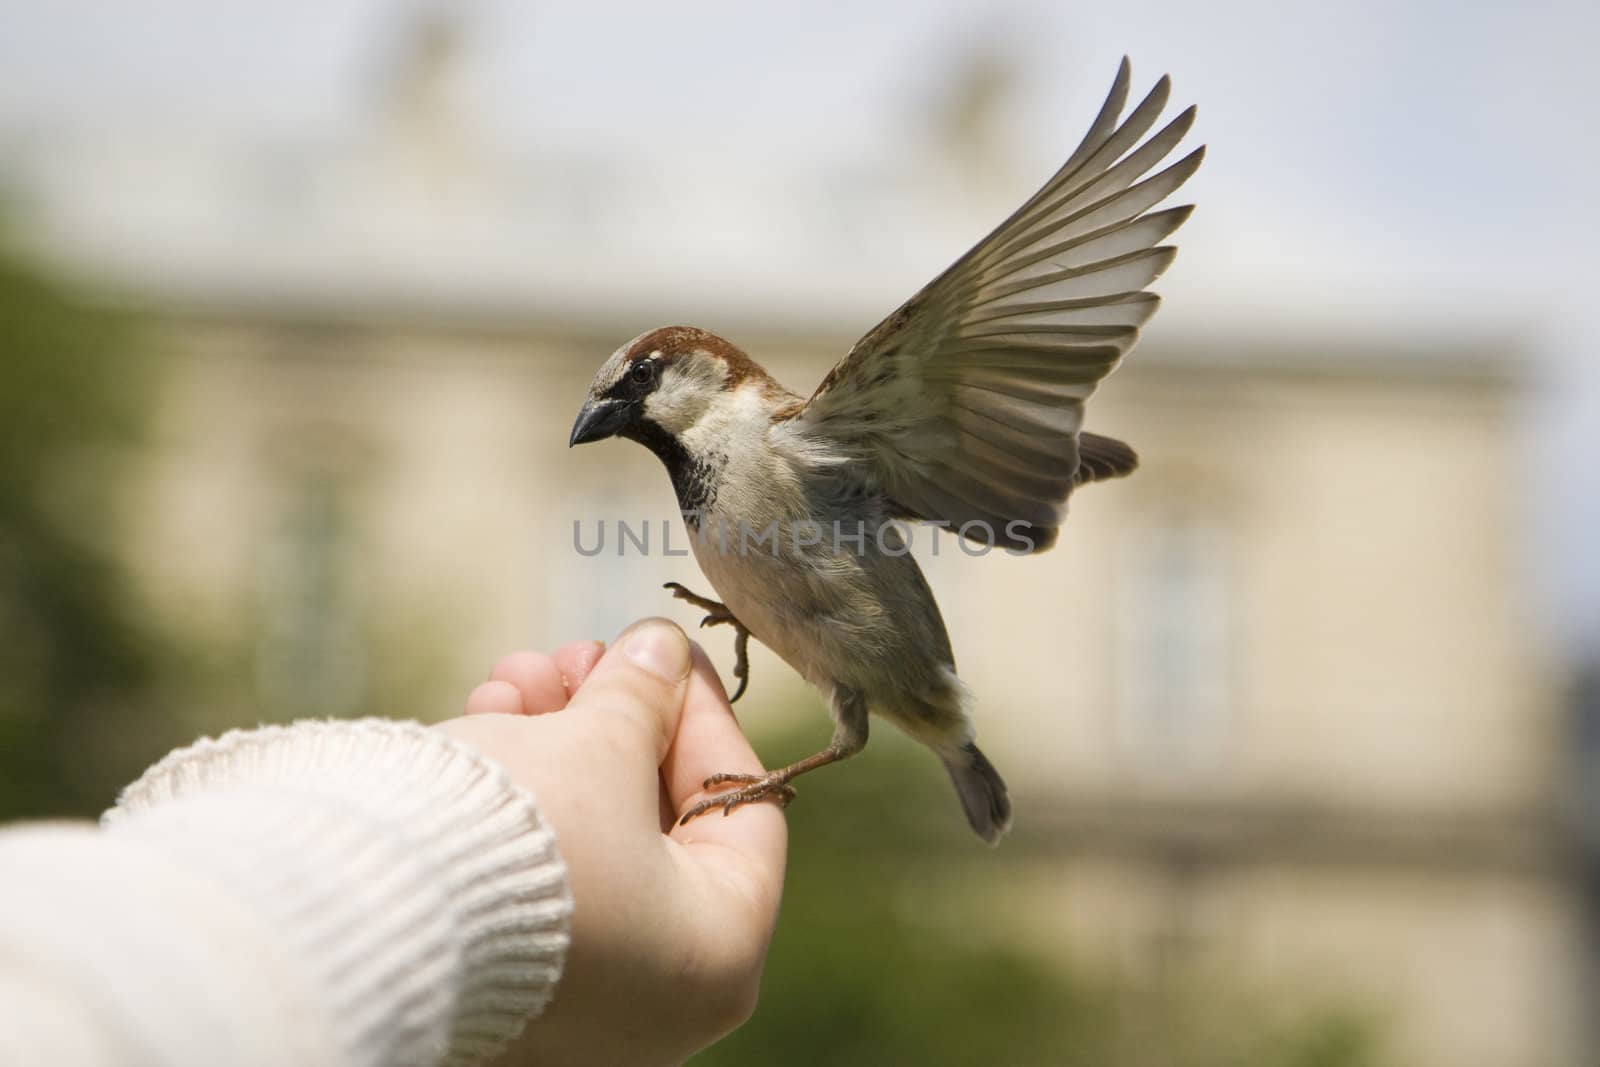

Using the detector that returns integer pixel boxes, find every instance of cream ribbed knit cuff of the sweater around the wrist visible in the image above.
[104,720,571,1065]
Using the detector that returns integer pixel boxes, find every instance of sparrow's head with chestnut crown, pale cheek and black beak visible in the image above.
[568,326,771,445]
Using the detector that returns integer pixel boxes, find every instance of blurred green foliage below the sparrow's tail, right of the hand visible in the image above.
[694,731,1379,1067]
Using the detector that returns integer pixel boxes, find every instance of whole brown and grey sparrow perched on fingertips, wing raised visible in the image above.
[568,58,1205,845]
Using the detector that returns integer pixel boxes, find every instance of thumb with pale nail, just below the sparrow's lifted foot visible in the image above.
[566,619,691,768]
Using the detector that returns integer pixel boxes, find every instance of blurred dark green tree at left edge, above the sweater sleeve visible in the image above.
[0,235,187,817]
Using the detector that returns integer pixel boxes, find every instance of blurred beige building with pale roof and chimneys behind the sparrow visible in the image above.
[3,14,1587,1067]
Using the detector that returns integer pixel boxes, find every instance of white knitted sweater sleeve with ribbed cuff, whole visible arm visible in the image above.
[0,720,571,1067]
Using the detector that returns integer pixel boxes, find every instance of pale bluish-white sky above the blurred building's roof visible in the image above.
[0,0,1600,656]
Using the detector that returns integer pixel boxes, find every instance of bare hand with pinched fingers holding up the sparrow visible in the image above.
[438,619,789,1064]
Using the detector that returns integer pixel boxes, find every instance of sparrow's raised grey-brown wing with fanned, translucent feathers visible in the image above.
[781,59,1205,552]
